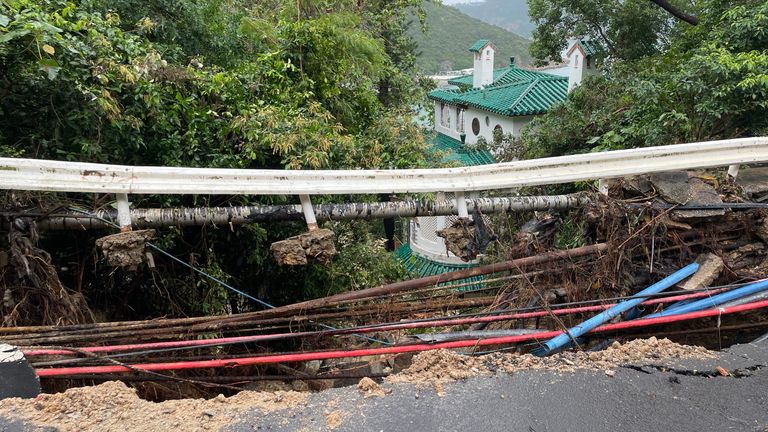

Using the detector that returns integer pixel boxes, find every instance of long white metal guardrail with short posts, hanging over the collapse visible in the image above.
[0,137,768,227]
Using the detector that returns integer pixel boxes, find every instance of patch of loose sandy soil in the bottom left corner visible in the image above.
[0,381,307,432]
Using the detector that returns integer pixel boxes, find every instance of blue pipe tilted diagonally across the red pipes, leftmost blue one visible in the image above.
[531,263,699,356]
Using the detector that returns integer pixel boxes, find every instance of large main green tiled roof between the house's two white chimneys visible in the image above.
[429,67,568,117]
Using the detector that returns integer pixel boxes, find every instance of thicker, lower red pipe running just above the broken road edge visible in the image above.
[35,300,768,377]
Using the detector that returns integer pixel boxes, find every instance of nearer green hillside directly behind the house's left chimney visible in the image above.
[410,2,530,73]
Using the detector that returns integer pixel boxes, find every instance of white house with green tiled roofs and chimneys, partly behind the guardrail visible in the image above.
[398,39,597,275]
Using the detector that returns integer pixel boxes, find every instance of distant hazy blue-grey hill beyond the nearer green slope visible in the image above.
[454,0,536,38]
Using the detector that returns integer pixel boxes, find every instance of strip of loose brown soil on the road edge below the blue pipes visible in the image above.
[388,337,717,386]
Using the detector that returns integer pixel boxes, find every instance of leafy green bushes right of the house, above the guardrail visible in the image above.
[523,0,768,157]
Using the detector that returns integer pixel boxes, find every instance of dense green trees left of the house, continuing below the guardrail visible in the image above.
[0,0,428,318]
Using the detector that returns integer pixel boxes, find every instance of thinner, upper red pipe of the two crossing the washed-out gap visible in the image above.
[22,288,725,357]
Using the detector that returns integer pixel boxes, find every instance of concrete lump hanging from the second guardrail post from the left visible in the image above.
[269,229,336,265]
